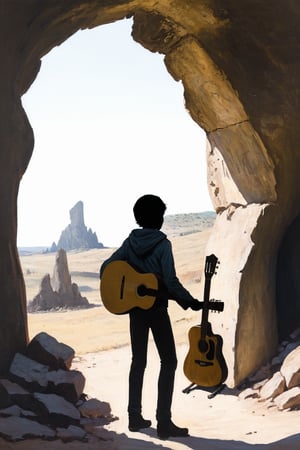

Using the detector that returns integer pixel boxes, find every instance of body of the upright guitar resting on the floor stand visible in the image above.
[183,324,227,387]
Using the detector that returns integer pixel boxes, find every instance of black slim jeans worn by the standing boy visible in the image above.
[128,305,177,421]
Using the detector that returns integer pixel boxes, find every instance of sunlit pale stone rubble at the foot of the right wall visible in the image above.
[239,328,300,410]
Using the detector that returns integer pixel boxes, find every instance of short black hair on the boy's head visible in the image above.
[133,194,167,230]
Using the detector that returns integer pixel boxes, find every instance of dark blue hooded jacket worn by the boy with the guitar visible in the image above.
[100,228,194,309]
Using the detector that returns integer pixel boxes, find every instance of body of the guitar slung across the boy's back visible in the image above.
[100,260,158,314]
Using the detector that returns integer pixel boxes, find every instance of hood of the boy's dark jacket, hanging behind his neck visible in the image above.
[128,228,167,256]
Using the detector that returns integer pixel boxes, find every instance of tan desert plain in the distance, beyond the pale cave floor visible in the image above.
[21,216,210,355]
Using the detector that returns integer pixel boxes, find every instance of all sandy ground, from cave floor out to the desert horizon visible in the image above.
[0,216,300,450]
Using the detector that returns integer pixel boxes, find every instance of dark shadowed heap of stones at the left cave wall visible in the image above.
[0,332,117,442]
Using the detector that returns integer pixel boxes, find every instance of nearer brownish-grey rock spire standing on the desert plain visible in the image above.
[28,249,90,312]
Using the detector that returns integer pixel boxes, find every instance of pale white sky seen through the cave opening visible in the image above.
[18,20,213,247]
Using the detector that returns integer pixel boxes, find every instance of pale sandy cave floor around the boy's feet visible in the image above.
[0,341,300,450]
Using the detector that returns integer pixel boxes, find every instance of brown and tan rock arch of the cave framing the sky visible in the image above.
[0,0,300,386]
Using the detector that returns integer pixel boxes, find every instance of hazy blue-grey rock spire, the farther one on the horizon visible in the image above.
[51,201,103,251]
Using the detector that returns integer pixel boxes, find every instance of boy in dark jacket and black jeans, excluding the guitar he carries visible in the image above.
[100,194,201,439]
